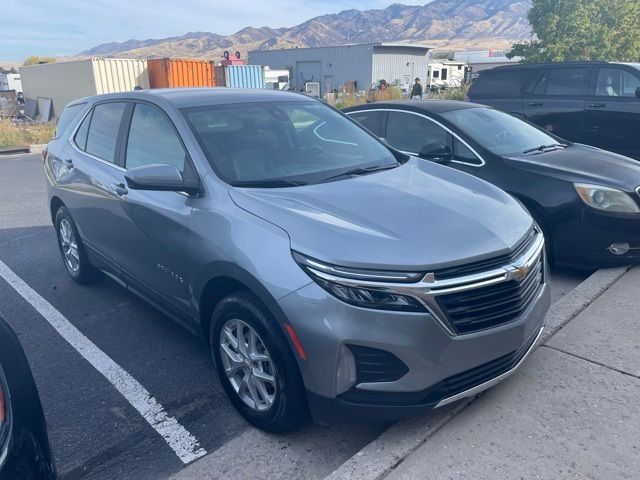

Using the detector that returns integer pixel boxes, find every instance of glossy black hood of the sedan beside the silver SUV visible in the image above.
[506,144,640,192]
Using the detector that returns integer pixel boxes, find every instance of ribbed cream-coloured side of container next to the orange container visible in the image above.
[91,58,149,93]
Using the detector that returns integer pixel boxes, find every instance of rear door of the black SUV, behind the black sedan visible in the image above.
[523,66,591,142]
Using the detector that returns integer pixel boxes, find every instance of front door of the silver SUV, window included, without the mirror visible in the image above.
[109,102,195,315]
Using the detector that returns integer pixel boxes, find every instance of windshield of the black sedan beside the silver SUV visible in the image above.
[442,107,565,155]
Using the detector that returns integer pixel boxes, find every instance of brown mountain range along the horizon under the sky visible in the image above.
[78,0,531,60]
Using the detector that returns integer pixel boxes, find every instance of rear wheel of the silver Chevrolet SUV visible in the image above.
[55,207,100,284]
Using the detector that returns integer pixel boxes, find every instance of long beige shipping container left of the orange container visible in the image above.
[20,58,149,120]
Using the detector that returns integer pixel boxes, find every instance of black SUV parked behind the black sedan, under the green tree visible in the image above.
[468,62,640,160]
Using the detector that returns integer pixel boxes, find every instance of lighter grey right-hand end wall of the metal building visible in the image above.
[371,46,429,84]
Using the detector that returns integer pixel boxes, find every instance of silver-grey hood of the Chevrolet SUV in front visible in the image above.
[229,158,532,271]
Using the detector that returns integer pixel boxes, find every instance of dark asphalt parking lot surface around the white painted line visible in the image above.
[0,155,588,480]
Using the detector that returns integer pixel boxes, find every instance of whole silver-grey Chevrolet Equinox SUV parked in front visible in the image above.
[44,88,550,431]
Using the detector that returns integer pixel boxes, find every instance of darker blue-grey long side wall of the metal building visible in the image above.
[249,44,374,94]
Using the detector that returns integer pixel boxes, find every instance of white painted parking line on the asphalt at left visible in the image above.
[0,260,207,463]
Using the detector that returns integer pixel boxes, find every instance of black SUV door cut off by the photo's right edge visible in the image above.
[584,65,640,159]
